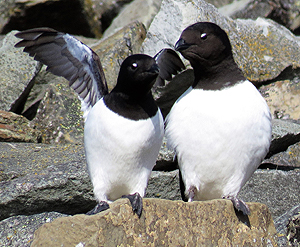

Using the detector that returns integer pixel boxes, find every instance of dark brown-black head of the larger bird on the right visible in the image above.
[175,22,232,67]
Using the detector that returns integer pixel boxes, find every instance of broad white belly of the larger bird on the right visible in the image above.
[166,81,271,200]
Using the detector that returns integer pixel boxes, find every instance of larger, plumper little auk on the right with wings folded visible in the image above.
[166,22,272,215]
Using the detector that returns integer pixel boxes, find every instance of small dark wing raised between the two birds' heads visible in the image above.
[154,49,185,87]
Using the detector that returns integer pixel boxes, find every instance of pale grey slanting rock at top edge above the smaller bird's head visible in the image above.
[103,0,162,37]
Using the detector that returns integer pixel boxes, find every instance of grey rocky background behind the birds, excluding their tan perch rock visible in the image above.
[0,0,300,246]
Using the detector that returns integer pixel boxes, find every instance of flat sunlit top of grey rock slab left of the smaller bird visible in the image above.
[0,142,85,182]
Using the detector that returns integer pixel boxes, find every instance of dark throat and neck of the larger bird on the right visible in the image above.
[192,56,245,90]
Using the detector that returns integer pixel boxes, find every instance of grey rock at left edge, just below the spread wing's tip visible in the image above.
[0,29,41,114]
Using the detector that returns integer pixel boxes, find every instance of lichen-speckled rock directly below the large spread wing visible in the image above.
[31,73,84,144]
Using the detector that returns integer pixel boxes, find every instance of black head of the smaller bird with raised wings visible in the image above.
[115,54,159,97]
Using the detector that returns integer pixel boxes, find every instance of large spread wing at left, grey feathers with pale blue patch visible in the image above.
[15,28,108,117]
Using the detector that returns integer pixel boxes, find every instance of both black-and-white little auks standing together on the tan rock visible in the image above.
[16,22,271,217]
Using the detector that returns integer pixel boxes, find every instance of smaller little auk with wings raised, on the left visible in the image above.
[15,28,184,217]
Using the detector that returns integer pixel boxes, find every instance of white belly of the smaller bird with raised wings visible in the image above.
[84,99,164,201]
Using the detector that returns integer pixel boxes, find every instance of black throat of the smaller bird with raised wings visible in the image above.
[104,90,158,121]
